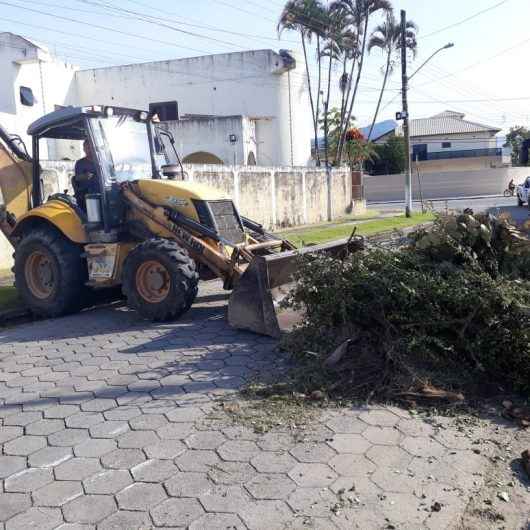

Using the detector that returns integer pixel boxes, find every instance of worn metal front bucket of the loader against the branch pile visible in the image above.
[228,239,359,338]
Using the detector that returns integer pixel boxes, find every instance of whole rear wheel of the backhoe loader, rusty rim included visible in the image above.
[13,228,87,318]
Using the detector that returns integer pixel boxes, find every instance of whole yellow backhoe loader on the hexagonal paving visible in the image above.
[0,106,351,336]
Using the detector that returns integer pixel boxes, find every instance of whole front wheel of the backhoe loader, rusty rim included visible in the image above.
[122,239,199,321]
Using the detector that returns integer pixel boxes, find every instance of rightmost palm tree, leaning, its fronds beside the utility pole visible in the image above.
[368,12,418,140]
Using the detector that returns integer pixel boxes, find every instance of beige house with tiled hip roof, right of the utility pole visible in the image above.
[374,110,510,173]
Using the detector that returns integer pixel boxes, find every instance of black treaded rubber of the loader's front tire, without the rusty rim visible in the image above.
[122,238,199,322]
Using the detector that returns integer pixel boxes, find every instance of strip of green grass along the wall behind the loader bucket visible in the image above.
[280,213,435,247]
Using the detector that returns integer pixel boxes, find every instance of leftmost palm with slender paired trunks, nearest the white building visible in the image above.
[278,0,327,165]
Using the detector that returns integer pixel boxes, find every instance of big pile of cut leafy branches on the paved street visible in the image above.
[284,214,530,403]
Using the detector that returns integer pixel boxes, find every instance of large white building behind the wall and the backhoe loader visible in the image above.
[0,33,312,166]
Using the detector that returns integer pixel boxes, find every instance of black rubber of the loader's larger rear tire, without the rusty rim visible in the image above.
[13,227,87,318]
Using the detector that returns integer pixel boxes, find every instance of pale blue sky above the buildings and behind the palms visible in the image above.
[0,0,530,129]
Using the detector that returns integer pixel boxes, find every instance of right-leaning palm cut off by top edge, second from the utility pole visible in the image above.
[330,0,392,163]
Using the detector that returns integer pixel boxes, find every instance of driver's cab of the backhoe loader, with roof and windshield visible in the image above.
[28,106,167,233]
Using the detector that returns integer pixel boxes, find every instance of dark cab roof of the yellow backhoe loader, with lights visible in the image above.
[28,105,147,140]
